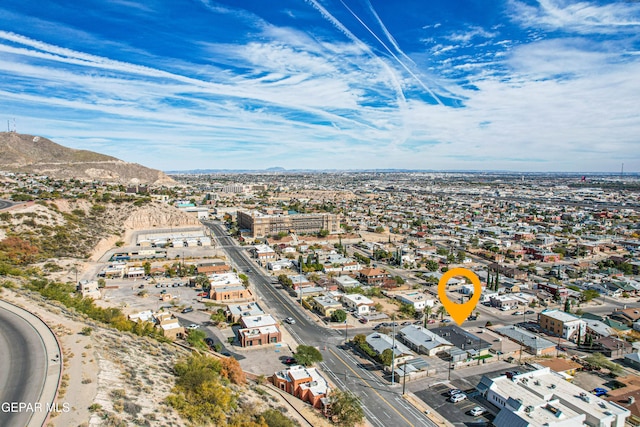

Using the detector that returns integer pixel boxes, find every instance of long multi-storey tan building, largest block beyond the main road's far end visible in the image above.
[238,211,340,238]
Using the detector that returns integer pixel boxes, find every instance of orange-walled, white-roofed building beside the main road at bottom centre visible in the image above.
[271,365,330,409]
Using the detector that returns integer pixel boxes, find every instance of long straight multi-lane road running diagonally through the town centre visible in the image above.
[205,221,436,427]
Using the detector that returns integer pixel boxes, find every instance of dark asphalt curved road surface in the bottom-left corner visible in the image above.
[0,308,47,427]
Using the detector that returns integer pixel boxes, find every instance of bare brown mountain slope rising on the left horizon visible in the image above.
[0,132,175,185]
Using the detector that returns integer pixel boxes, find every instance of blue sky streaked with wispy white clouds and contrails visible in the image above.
[0,0,640,172]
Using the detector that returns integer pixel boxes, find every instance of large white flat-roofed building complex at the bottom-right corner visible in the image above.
[477,368,630,427]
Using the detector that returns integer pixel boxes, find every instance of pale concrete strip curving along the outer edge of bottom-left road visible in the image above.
[0,300,62,427]
